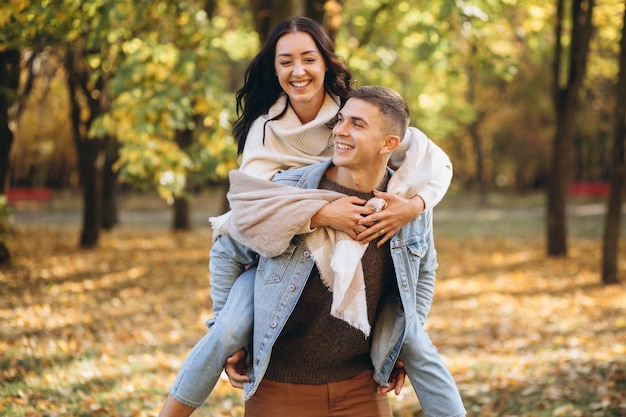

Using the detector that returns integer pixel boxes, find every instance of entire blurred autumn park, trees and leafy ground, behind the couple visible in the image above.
[0,0,626,417]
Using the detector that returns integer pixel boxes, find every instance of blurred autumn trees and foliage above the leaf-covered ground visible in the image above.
[0,0,626,256]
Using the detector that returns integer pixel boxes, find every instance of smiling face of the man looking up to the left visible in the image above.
[333,98,385,168]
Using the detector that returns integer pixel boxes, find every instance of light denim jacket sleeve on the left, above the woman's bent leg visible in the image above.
[209,235,258,317]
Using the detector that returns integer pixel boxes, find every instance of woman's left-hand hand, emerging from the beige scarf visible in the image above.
[311,197,374,239]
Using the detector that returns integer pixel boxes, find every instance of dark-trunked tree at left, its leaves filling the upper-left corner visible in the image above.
[0,0,141,247]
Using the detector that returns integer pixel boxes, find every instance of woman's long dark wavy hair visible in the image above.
[233,17,352,154]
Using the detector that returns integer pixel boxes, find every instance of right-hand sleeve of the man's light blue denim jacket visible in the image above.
[415,210,438,325]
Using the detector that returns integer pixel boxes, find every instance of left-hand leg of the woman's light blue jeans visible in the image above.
[170,268,256,408]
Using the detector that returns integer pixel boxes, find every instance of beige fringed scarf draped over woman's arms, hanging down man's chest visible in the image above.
[210,128,447,336]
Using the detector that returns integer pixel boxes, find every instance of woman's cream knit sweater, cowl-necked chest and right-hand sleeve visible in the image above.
[234,94,452,207]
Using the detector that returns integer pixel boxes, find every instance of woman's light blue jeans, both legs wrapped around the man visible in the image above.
[170,268,465,417]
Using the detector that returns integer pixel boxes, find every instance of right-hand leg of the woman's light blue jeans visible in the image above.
[398,320,466,417]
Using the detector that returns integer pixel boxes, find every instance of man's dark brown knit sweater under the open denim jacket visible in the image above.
[265,171,395,384]
